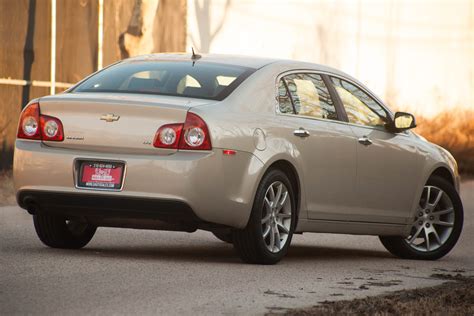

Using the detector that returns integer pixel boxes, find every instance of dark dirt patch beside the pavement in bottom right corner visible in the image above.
[283,274,474,316]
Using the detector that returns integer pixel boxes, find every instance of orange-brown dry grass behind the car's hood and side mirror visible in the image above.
[415,110,474,175]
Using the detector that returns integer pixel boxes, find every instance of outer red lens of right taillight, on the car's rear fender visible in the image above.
[179,112,212,150]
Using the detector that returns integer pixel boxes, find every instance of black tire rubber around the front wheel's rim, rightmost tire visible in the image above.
[379,176,464,260]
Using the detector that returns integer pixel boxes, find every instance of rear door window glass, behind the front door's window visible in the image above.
[279,73,337,120]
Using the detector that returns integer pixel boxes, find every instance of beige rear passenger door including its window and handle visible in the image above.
[279,72,356,219]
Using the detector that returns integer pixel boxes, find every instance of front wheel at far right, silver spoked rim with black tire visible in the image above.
[380,177,463,260]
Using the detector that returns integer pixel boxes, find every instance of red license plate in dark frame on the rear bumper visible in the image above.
[77,161,124,190]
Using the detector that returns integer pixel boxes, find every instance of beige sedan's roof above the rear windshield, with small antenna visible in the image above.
[123,53,347,76]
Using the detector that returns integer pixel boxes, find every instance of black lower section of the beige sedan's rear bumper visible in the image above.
[17,190,208,231]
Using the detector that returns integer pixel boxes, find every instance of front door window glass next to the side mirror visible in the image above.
[331,77,389,127]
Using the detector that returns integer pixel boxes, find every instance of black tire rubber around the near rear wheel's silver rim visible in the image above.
[232,169,297,264]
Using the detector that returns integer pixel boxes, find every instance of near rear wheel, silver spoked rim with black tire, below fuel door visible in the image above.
[233,169,296,264]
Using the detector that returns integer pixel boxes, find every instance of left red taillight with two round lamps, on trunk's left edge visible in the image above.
[17,103,64,142]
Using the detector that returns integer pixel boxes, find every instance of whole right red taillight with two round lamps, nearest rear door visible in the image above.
[153,112,212,150]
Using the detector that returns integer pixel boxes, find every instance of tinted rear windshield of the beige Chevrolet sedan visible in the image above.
[72,61,255,100]
